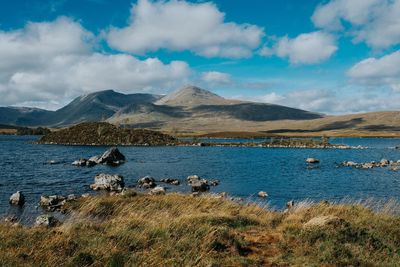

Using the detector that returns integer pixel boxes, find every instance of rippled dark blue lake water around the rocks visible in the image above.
[0,136,400,223]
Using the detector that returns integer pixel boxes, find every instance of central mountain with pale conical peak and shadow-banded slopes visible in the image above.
[108,86,323,128]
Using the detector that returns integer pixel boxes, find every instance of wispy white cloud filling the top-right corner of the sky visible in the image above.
[312,0,400,48]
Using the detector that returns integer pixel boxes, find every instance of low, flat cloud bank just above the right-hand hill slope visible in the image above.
[252,89,400,114]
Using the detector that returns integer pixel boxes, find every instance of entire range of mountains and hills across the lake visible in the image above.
[0,86,400,136]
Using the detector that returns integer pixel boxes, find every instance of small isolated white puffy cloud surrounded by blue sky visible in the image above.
[261,31,338,64]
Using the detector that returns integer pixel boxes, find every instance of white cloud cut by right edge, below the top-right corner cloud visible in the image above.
[347,51,400,90]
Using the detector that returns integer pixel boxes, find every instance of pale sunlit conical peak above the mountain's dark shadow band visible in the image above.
[156,85,239,107]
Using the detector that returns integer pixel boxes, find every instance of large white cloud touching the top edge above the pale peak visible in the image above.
[107,0,264,58]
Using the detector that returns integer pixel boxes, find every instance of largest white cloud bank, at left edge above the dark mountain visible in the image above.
[0,17,191,107]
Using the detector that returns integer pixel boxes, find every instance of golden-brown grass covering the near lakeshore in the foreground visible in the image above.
[0,194,400,266]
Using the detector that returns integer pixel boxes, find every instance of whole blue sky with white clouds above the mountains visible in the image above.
[0,0,400,114]
